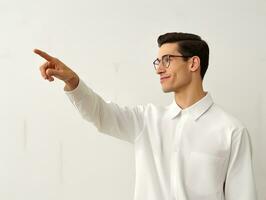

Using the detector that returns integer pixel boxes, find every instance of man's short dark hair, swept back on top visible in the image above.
[157,32,209,79]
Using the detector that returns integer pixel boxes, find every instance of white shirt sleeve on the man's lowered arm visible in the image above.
[225,128,257,200]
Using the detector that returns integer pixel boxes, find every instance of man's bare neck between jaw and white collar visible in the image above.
[175,81,207,109]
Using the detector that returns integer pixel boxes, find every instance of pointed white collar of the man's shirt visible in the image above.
[168,92,213,121]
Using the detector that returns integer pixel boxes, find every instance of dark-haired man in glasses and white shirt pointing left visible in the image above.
[35,33,256,200]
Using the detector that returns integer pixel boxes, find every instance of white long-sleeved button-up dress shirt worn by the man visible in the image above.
[66,80,257,200]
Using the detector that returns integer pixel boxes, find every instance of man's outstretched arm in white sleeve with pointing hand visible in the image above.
[34,49,147,143]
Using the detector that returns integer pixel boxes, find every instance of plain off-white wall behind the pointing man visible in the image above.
[0,0,266,200]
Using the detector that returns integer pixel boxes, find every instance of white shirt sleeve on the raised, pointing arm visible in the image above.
[65,79,145,143]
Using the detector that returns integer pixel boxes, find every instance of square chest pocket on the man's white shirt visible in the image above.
[185,152,225,196]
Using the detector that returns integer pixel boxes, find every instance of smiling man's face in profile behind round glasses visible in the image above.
[156,43,192,92]
